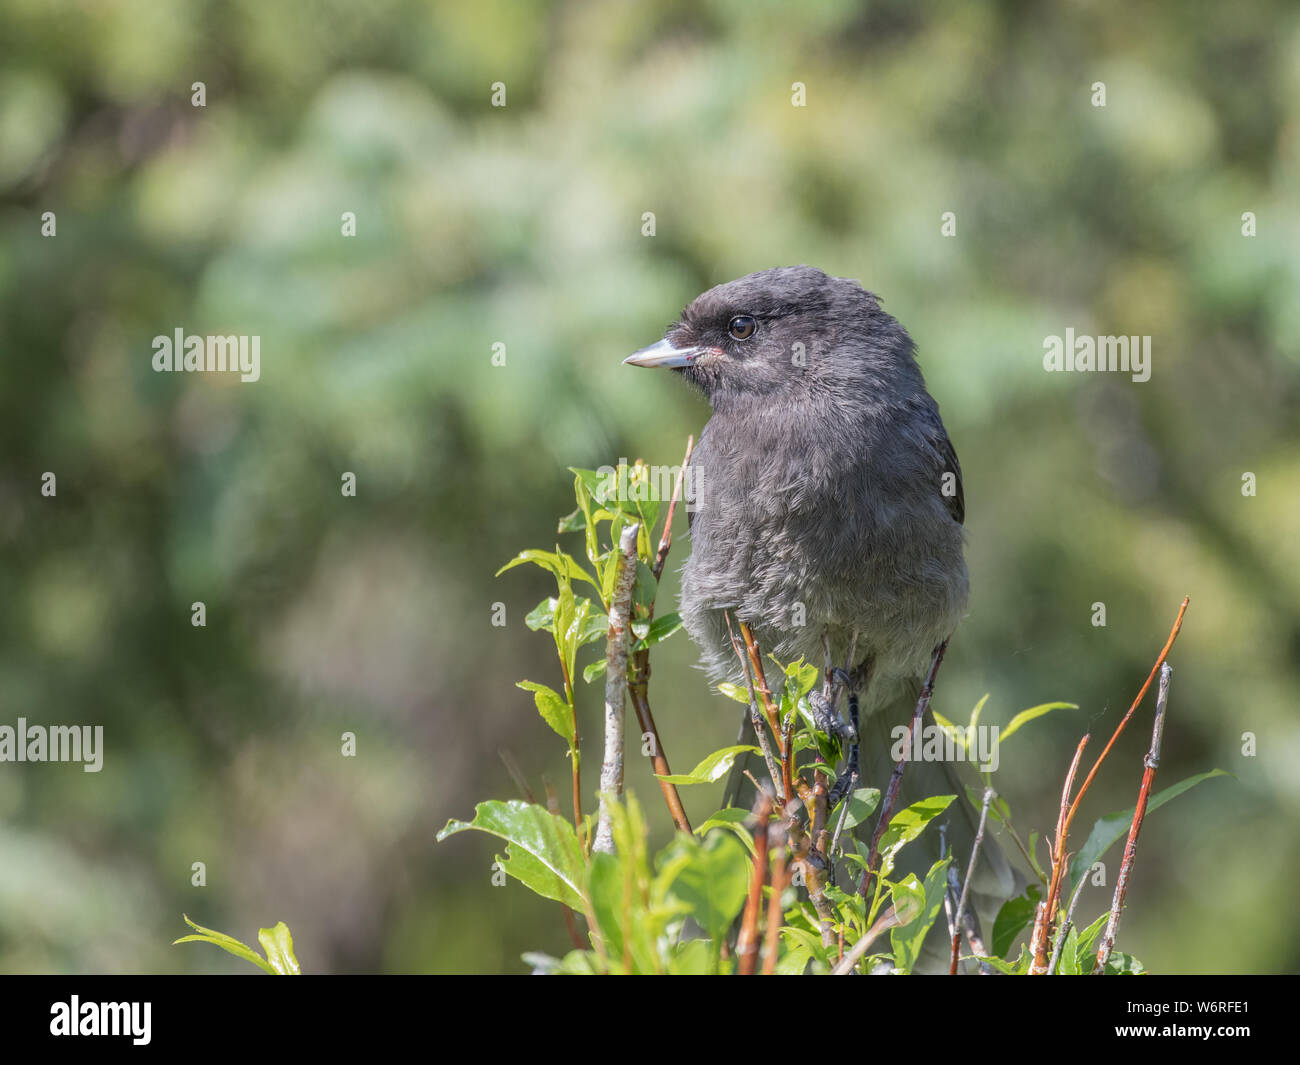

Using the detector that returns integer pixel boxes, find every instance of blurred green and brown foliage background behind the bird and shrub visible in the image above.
[0,0,1300,973]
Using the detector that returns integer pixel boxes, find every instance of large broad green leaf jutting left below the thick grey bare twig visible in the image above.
[438,798,586,912]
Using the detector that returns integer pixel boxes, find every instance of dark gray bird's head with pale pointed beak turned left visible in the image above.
[624,267,915,407]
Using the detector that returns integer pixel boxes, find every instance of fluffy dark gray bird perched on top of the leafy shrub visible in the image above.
[625,267,1014,967]
